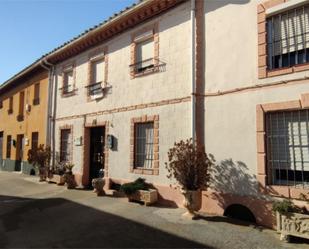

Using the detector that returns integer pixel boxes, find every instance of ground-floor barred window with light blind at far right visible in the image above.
[266,110,309,188]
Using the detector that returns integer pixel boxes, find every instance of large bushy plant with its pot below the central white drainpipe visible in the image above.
[165,139,215,218]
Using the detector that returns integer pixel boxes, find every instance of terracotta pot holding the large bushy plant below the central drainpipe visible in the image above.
[182,190,201,219]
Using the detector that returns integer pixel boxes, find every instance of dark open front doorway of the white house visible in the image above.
[89,127,105,185]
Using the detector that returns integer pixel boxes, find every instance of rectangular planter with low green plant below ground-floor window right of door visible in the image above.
[120,178,158,206]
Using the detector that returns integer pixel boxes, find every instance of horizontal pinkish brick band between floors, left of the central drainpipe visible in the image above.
[56,97,191,121]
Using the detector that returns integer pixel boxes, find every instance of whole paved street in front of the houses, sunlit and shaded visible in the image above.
[0,172,309,249]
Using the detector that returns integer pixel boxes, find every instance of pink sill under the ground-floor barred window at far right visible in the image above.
[261,185,309,199]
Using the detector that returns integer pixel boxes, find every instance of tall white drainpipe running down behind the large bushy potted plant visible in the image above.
[191,0,196,145]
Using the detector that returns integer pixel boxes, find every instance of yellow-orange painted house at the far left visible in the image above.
[0,66,48,174]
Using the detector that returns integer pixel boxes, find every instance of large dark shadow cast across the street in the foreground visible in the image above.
[0,196,211,248]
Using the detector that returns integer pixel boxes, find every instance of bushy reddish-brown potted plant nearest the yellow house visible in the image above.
[28,144,51,181]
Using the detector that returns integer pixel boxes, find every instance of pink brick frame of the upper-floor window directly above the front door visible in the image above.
[86,46,108,102]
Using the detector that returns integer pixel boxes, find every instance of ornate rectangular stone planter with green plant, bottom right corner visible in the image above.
[272,199,309,242]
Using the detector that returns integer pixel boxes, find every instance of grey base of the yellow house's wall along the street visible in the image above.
[0,159,38,175]
